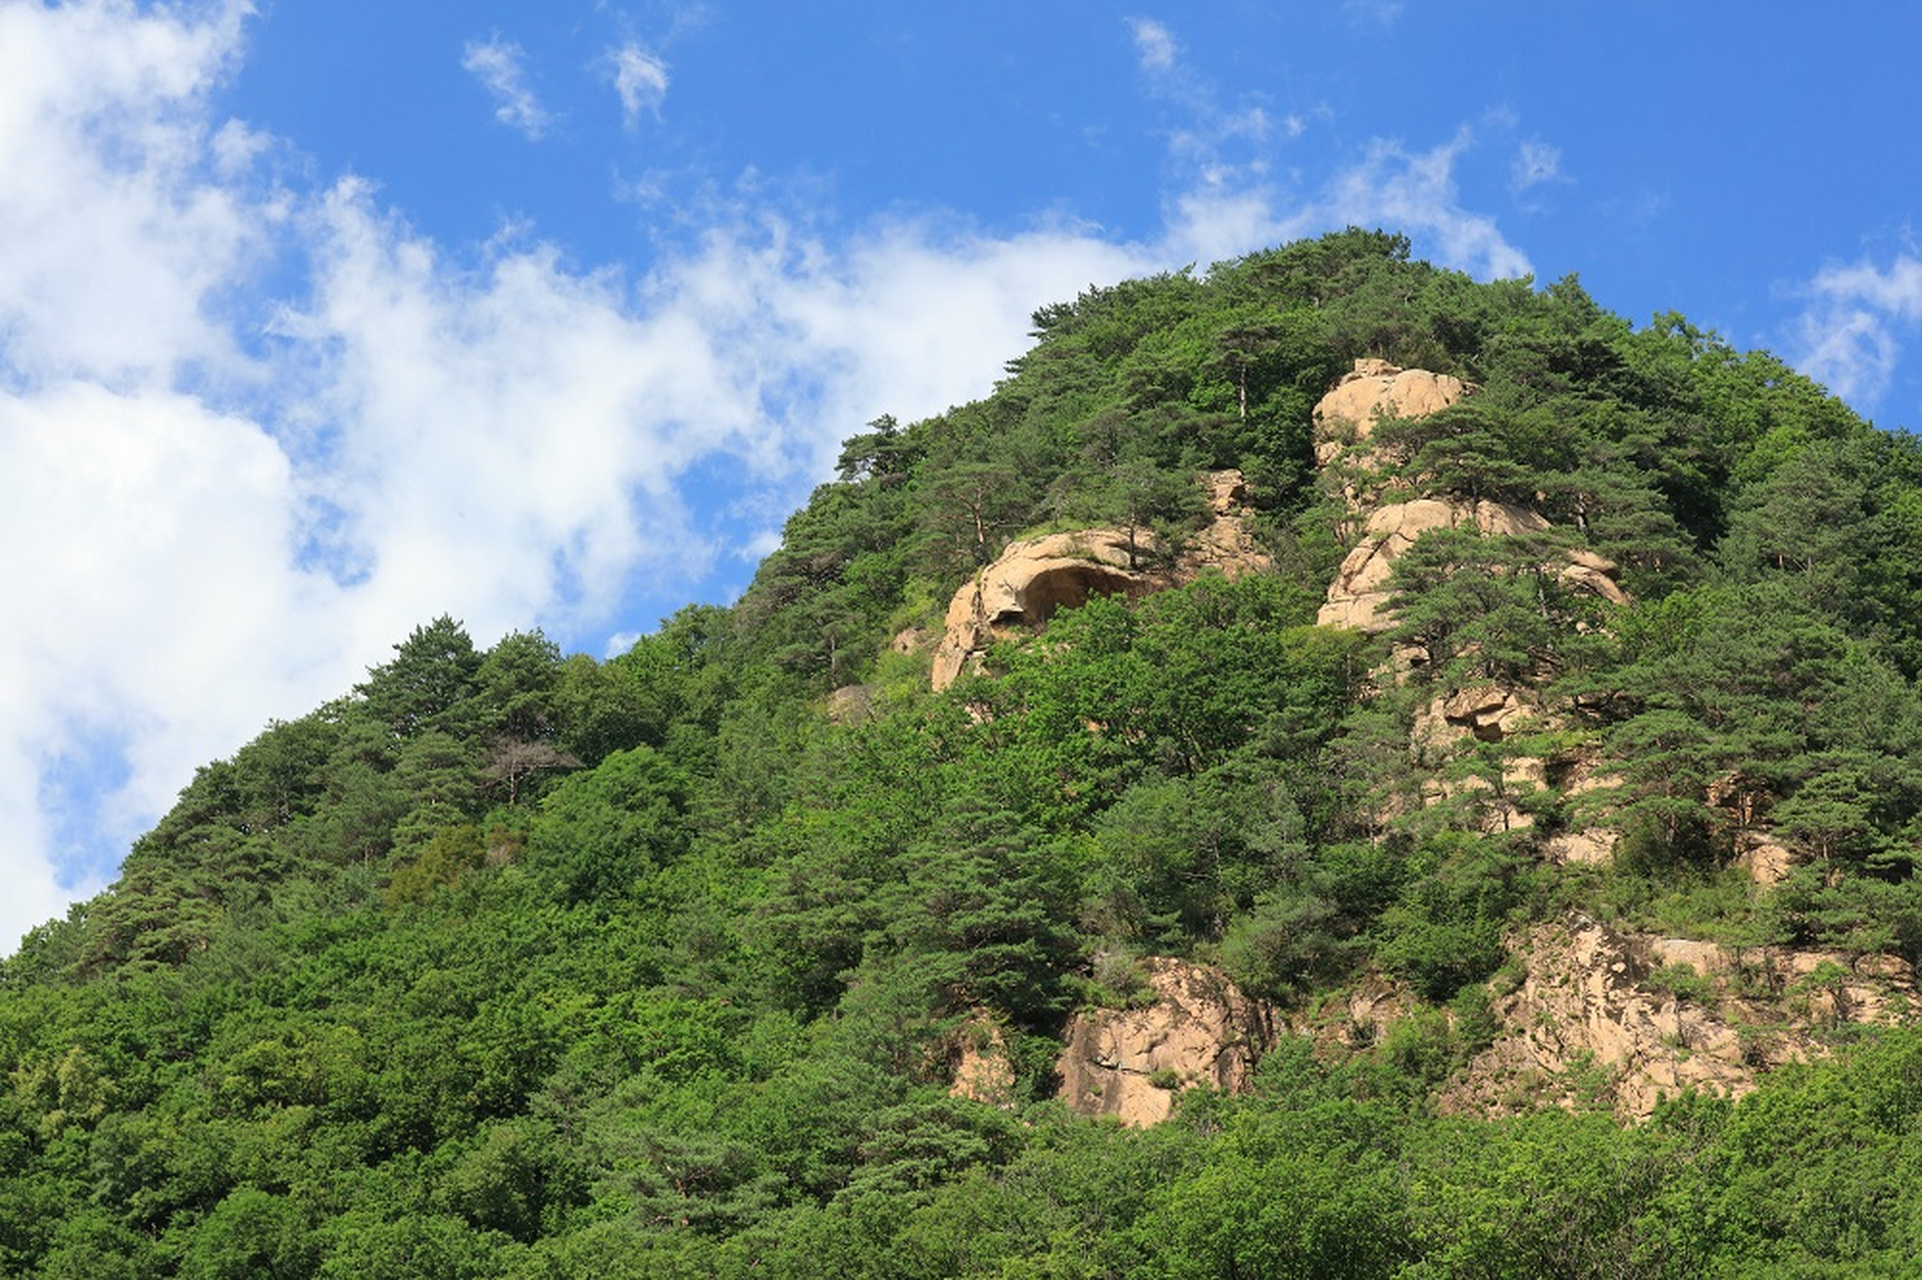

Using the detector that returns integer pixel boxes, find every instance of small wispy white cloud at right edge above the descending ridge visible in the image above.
[1791,254,1922,406]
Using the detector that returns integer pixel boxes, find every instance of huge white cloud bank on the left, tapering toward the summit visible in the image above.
[0,4,1149,946]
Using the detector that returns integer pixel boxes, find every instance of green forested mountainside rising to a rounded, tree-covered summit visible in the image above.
[0,231,1922,1280]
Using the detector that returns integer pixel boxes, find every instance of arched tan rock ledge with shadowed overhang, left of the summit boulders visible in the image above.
[934,469,1269,690]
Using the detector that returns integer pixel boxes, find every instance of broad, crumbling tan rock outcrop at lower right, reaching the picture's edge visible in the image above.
[1443,915,1914,1119]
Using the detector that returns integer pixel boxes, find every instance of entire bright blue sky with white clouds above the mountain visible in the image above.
[0,0,1922,946]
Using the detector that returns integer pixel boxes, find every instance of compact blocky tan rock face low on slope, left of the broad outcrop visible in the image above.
[1055,957,1274,1124]
